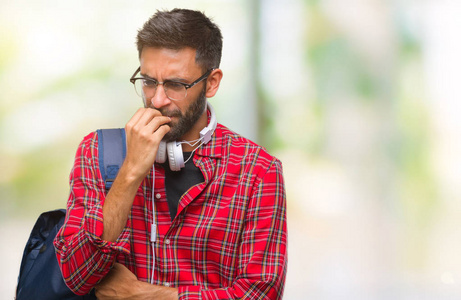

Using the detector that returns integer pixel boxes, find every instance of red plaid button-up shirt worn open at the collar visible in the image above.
[55,124,287,299]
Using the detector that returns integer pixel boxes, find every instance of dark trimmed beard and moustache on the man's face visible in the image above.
[157,86,206,142]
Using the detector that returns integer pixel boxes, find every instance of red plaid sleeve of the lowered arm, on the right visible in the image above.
[178,158,288,300]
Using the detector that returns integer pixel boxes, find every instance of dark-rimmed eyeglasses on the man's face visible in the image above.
[130,67,214,101]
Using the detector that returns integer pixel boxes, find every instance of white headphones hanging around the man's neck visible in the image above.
[155,101,217,171]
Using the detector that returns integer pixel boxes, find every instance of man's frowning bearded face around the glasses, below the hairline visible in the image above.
[140,48,206,142]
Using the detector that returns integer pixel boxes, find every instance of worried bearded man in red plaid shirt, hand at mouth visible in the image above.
[55,9,287,299]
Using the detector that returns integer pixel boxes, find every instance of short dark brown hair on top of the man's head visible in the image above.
[136,8,222,70]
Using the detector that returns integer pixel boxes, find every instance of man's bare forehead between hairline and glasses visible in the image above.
[140,47,201,78]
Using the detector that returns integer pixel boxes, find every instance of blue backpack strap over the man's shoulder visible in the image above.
[96,128,126,191]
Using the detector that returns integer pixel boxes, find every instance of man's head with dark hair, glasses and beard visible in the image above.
[130,9,223,141]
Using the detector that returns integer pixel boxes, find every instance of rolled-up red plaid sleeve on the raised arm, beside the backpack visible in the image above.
[54,133,130,295]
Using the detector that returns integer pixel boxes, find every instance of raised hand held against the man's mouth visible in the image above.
[125,108,171,180]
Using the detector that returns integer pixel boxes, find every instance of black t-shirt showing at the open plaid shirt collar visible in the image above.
[162,152,205,221]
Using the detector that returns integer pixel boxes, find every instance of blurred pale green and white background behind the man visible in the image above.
[0,0,461,299]
